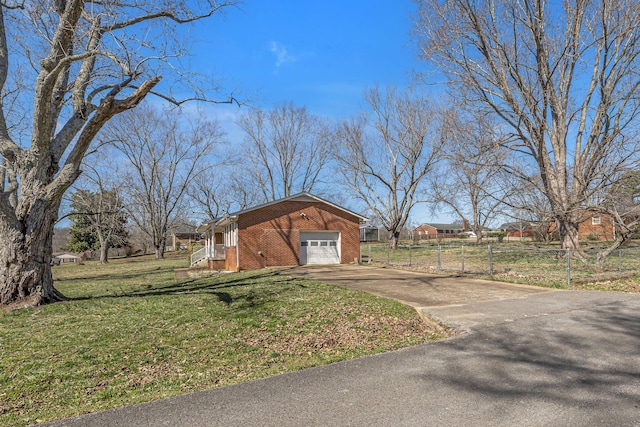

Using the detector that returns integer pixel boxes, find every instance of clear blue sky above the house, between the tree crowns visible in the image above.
[182,0,448,222]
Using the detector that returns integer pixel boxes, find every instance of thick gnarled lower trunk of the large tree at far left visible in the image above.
[0,202,65,306]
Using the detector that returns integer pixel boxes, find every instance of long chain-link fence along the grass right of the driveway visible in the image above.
[360,244,640,285]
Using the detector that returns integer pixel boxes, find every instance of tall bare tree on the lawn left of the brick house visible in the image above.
[100,105,222,259]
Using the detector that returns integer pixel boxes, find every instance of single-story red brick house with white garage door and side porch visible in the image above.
[192,193,367,271]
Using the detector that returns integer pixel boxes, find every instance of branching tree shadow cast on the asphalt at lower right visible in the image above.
[418,300,640,425]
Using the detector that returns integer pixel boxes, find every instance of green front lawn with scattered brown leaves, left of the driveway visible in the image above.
[0,257,438,426]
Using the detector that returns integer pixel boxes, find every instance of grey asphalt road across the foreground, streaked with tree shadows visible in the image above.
[45,268,640,426]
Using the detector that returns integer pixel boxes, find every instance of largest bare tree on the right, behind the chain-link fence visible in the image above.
[415,0,640,257]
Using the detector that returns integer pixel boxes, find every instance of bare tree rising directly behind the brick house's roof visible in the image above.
[237,104,333,201]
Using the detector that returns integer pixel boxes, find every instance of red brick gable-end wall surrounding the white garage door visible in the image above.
[238,201,360,270]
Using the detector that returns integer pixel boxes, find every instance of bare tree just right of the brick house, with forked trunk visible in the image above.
[337,88,442,248]
